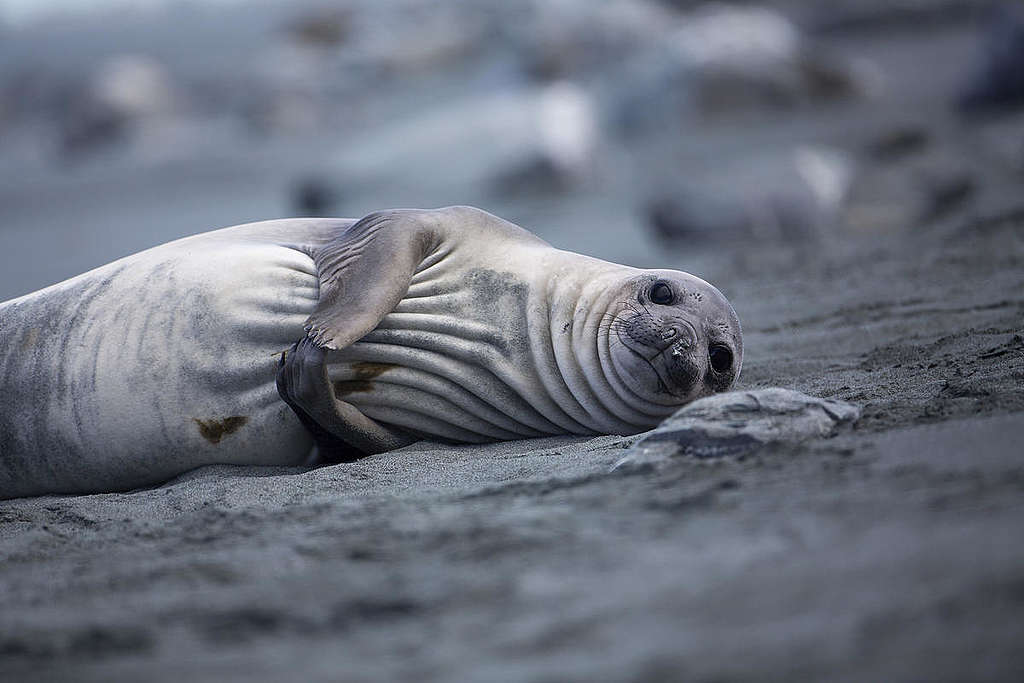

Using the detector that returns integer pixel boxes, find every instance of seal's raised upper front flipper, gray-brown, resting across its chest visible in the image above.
[305,209,437,349]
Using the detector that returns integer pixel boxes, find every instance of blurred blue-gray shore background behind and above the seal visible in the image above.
[0,0,1024,299]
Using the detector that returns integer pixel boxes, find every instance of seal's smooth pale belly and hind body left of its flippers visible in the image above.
[0,240,317,498]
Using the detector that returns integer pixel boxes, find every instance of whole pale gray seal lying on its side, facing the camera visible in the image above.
[0,207,742,498]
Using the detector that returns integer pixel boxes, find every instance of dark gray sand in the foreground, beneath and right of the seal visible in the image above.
[0,225,1024,681]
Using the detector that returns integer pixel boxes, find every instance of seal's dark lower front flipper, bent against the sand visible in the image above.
[278,337,416,462]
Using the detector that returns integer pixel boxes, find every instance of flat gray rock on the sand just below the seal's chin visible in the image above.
[612,387,860,470]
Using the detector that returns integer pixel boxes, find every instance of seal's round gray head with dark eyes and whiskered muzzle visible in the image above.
[608,270,743,405]
